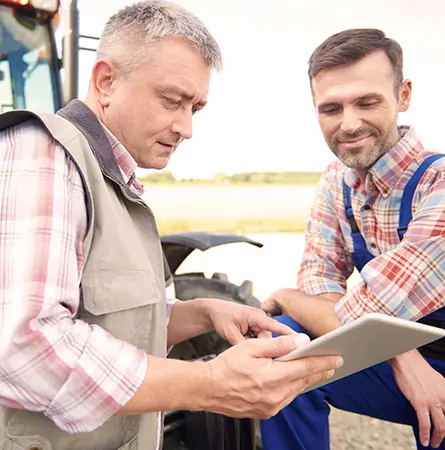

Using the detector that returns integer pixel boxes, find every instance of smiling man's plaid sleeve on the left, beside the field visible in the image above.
[298,163,354,295]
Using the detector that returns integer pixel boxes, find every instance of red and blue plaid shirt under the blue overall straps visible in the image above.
[298,127,445,323]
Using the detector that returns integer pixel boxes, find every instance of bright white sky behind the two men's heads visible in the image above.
[71,0,445,178]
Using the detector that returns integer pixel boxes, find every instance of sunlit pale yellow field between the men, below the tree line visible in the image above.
[140,183,315,234]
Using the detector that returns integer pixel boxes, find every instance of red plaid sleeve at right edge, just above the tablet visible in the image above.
[336,167,445,323]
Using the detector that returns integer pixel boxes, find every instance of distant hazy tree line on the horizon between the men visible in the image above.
[139,170,321,185]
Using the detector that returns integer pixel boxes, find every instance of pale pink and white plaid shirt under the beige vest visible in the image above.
[0,118,176,433]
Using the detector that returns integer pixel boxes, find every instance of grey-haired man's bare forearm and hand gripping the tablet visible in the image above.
[119,333,342,419]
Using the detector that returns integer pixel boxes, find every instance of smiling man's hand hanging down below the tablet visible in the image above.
[390,350,445,448]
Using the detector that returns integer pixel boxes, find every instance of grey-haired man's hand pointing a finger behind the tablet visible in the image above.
[205,299,296,345]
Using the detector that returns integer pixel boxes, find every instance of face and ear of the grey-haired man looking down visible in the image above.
[87,37,211,169]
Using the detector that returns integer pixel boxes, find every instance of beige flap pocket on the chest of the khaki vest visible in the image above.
[82,270,165,316]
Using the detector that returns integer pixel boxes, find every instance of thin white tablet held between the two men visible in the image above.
[276,313,445,392]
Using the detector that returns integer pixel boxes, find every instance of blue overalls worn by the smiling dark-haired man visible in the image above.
[261,155,445,450]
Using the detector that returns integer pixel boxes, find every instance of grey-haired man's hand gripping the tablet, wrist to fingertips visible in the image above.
[201,334,342,419]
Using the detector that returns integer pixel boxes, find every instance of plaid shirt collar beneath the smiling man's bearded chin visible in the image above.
[345,126,423,198]
